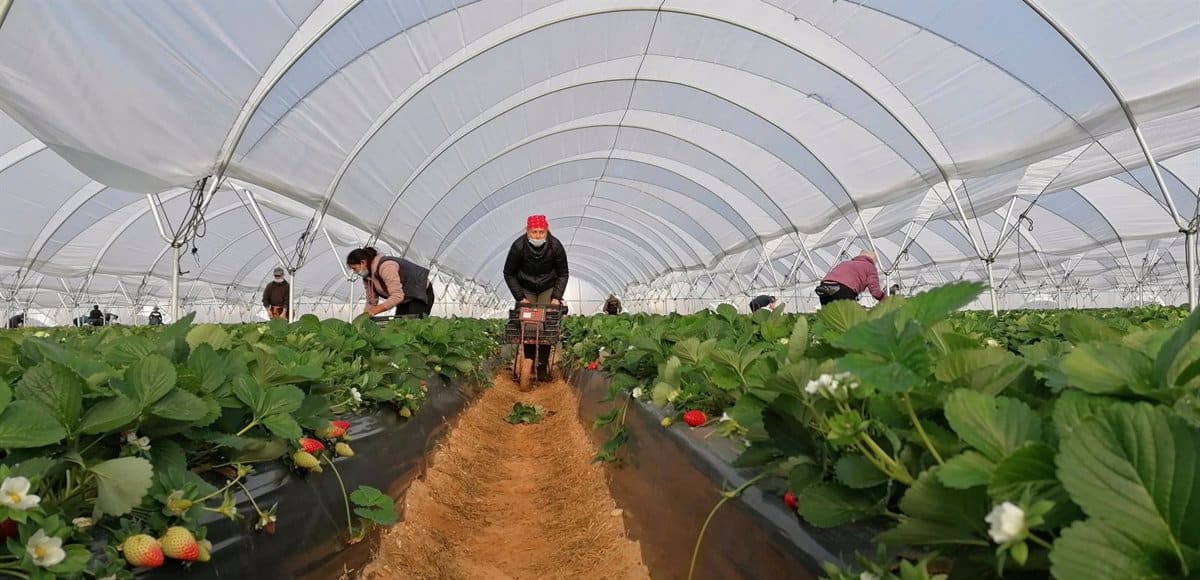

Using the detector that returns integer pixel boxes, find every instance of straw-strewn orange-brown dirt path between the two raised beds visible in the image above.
[361,372,649,580]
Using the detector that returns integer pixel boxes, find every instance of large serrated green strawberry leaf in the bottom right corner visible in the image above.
[1050,403,1200,578]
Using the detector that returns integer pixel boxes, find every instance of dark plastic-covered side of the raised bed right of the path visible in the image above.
[569,370,878,580]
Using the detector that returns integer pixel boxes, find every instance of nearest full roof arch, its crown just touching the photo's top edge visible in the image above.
[288,6,964,272]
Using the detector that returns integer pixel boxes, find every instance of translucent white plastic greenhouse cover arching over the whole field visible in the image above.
[0,0,1200,321]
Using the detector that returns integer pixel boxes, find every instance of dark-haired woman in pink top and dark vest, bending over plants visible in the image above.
[346,247,433,318]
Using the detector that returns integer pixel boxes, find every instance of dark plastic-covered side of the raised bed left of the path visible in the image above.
[143,363,496,579]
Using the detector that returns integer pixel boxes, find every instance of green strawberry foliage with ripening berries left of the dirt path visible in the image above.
[0,316,499,579]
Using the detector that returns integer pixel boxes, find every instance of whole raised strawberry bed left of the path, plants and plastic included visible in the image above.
[0,316,500,580]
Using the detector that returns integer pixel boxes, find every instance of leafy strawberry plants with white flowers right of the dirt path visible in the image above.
[569,283,1200,579]
